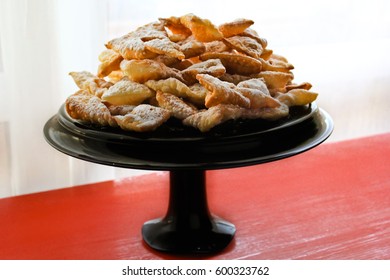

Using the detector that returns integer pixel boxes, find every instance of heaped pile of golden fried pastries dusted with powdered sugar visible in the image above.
[65,14,317,132]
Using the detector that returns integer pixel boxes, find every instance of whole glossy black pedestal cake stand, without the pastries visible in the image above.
[44,103,333,254]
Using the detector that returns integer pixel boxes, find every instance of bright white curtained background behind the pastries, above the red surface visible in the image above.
[0,0,390,198]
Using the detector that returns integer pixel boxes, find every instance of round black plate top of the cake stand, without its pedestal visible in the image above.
[44,101,333,170]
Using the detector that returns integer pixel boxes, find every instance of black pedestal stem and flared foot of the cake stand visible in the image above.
[142,169,236,254]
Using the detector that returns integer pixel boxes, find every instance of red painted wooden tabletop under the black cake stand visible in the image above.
[0,134,390,259]
